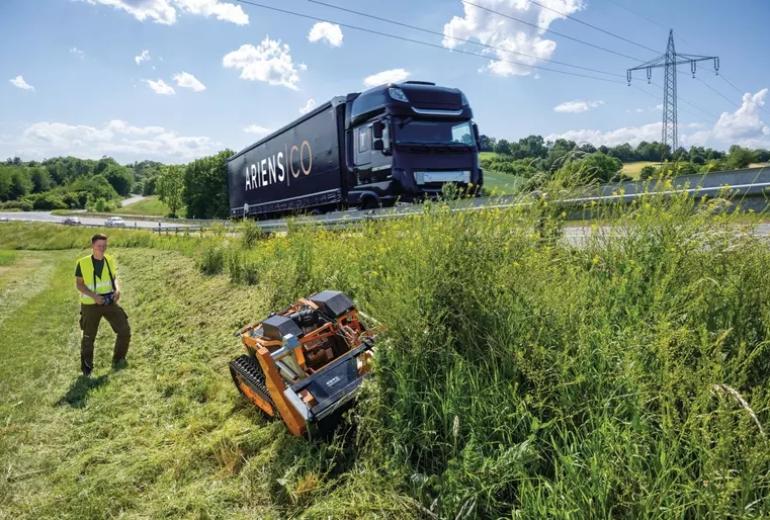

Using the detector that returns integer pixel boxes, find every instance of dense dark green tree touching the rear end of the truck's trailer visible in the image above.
[182,150,233,218]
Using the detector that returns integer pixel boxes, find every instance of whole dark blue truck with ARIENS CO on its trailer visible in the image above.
[227,81,483,218]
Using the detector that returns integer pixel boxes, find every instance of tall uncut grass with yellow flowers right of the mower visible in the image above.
[0,186,770,519]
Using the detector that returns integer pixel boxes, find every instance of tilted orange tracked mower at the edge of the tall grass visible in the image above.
[230,291,376,435]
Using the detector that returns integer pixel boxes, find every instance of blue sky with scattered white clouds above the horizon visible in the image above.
[0,0,770,163]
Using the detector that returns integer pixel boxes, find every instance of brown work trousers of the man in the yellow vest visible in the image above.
[80,303,131,373]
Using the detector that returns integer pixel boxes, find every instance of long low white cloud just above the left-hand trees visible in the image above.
[8,119,223,162]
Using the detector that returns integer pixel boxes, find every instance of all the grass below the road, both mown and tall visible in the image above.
[0,192,770,519]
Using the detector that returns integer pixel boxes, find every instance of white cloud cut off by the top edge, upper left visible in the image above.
[86,0,249,25]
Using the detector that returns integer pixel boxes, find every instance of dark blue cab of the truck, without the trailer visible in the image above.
[344,81,483,208]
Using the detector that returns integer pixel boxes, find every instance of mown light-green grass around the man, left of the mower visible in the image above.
[0,249,380,519]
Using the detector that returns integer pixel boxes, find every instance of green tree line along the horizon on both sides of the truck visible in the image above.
[0,135,770,218]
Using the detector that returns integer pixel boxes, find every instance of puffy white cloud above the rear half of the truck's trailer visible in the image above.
[222,36,304,90]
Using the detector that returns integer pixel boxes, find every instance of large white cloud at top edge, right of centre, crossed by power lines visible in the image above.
[442,0,583,76]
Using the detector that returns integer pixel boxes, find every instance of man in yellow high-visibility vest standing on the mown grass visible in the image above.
[75,233,131,377]
